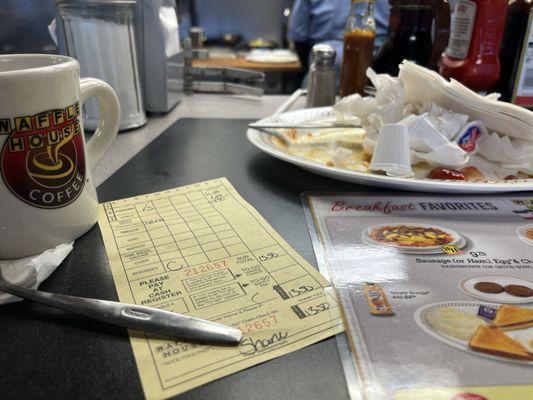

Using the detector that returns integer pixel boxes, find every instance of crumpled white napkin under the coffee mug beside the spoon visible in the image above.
[0,242,74,305]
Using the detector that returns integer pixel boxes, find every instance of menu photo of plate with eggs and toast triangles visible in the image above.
[415,301,533,366]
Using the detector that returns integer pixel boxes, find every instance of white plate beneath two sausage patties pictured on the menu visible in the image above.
[459,276,533,304]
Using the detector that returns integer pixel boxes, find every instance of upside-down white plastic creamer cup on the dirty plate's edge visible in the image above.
[370,124,413,177]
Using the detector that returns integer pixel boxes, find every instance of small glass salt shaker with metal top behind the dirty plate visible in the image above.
[307,43,336,107]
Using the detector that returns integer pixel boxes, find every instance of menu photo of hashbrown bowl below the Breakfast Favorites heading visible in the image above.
[362,222,467,254]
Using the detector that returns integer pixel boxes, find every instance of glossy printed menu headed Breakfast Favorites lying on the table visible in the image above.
[303,193,533,400]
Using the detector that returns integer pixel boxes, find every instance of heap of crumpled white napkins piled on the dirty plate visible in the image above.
[333,62,533,180]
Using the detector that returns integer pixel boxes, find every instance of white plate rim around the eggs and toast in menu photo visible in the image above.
[414,301,533,366]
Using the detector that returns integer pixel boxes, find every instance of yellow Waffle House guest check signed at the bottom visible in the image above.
[99,178,343,399]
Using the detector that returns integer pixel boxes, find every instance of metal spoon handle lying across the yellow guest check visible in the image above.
[0,269,242,345]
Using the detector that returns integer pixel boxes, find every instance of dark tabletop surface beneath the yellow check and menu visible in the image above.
[0,119,382,400]
